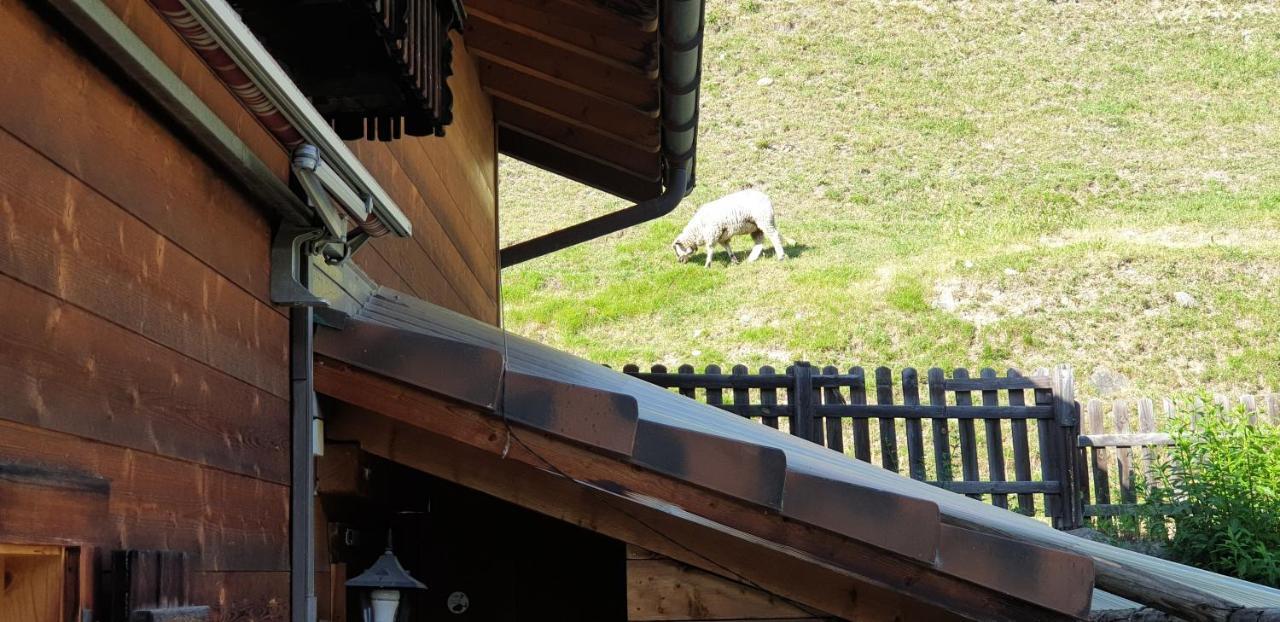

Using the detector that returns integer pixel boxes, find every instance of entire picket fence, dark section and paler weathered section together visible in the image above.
[623,361,1280,529]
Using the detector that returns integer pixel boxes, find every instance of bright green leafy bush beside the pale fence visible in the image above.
[1143,404,1280,586]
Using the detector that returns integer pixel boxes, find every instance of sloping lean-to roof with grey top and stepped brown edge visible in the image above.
[316,289,1280,614]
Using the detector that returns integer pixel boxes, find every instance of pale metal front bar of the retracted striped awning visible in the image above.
[157,0,413,237]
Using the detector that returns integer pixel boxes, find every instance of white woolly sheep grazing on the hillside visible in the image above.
[671,189,787,267]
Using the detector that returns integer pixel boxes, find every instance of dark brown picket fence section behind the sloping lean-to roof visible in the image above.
[623,361,1083,529]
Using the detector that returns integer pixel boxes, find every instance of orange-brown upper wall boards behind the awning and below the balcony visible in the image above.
[90,0,498,323]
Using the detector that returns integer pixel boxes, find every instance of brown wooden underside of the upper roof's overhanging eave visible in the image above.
[466,0,663,202]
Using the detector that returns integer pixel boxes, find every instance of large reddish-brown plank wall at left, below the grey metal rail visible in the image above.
[0,0,289,621]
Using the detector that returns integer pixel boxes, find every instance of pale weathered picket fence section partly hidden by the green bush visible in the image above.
[1078,393,1280,517]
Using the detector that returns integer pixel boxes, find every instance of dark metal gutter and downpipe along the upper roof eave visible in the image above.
[496,0,705,267]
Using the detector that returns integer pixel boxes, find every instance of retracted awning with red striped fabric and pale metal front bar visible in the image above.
[151,0,413,237]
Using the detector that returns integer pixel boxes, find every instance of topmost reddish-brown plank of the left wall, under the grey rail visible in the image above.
[0,3,271,307]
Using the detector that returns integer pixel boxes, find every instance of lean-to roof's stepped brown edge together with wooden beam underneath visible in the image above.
[309,291,1093,619]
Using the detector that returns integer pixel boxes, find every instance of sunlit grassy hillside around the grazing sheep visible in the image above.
[500,0,1280,394]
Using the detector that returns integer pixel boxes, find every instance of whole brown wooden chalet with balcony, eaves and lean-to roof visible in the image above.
[0,0,1275,622]
